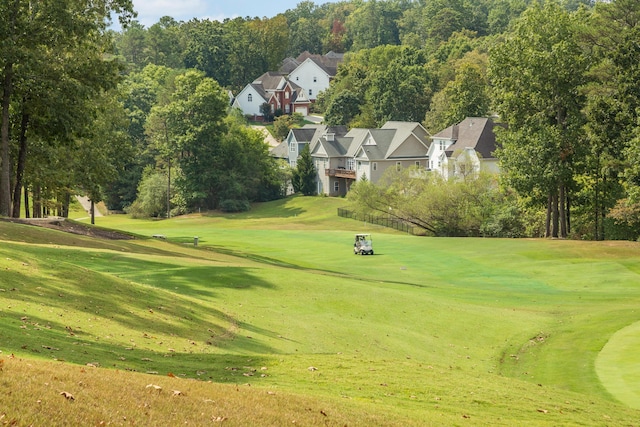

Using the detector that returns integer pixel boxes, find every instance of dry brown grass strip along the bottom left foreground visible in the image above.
[0,357,411,426]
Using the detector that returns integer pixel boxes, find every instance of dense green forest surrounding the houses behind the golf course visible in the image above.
[0,0,640,239]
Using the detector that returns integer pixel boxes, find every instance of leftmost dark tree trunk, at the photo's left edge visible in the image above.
[0,62,13,216]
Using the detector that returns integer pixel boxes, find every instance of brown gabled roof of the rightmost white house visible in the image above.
[433,117,502,159]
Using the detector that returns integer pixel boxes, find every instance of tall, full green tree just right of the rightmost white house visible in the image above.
[490,1,587,237]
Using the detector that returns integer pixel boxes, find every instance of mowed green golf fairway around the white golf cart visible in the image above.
[0,198,640,425]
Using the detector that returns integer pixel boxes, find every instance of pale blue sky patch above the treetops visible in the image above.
[126,0,338,28]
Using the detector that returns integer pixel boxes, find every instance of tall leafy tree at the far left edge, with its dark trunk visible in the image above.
[0,0,133,216]
